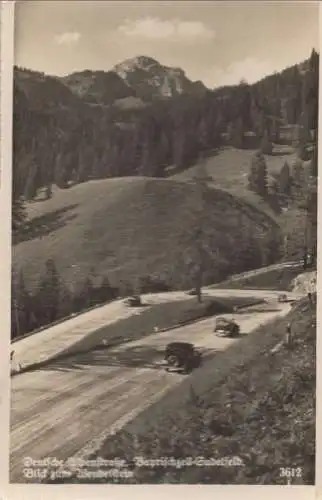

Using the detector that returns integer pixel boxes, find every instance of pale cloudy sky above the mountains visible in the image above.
[15,0,319,88]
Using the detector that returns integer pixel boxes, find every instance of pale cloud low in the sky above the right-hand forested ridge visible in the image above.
[208,57,283,87]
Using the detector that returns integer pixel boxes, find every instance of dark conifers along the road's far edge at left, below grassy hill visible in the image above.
[11,259,176,339]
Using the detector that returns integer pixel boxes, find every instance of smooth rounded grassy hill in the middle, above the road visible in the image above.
[13,178,272,289]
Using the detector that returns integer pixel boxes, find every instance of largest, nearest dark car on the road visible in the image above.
[164,342,201,373]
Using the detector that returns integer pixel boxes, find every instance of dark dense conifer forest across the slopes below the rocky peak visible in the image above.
[13,51,319,199]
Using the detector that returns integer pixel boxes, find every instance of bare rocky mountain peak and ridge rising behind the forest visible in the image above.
[15,56,208,105]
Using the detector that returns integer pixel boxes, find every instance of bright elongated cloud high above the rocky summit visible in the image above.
[118,17,215,42]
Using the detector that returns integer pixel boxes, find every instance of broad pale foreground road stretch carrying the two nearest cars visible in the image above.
[10,290,291,482]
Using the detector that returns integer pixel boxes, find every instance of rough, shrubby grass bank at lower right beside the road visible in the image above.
[59,301,316,484]
